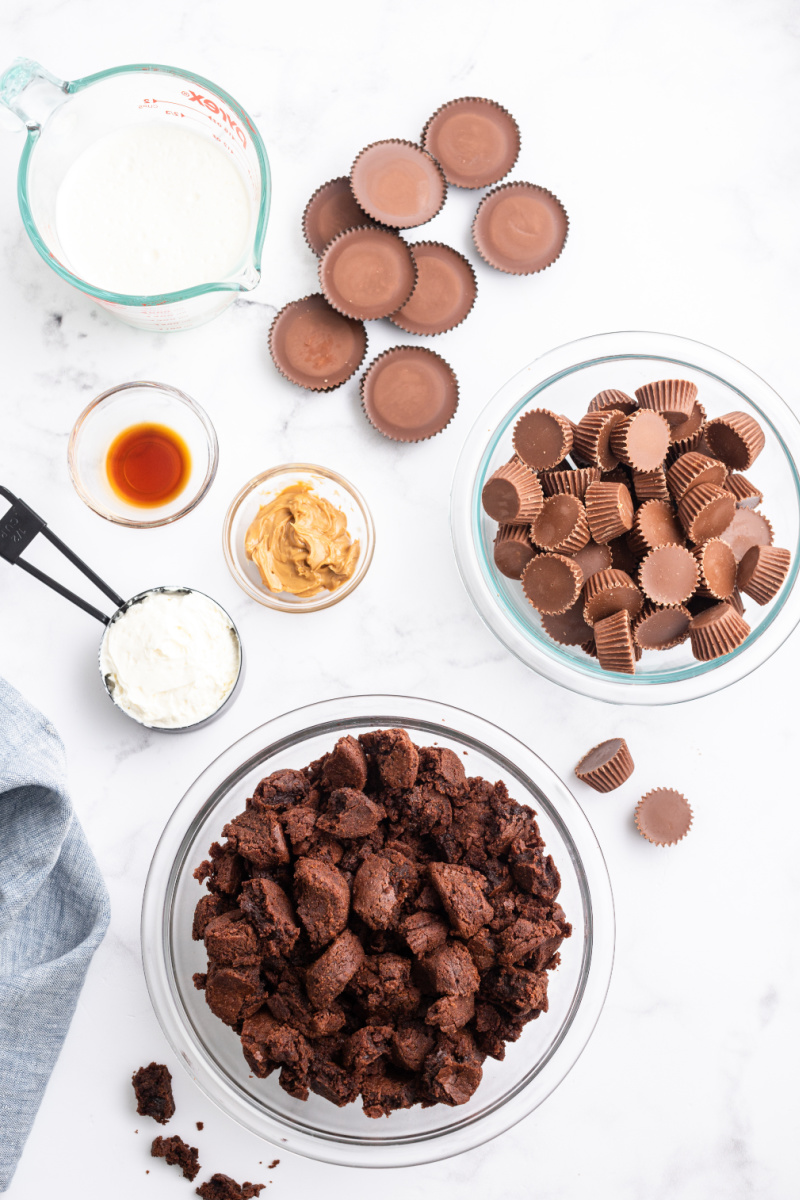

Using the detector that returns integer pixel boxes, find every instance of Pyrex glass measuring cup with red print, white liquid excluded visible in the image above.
[0,59,271,332]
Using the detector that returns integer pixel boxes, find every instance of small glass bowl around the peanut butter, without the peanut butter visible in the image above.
[222,462,375,612]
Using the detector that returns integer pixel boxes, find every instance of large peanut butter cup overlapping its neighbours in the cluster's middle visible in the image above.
[319,226,416,320]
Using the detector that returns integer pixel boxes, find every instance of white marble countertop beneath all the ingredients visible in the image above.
[0,0,800,1200]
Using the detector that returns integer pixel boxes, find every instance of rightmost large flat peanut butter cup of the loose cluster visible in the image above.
[473,184,570,275]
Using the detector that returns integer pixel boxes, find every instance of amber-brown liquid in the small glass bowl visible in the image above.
[106,424,192,509]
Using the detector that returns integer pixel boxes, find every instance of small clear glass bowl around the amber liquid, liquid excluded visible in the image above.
[67,379,219,529]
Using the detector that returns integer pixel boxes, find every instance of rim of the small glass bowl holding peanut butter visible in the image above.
[222,462,375,613]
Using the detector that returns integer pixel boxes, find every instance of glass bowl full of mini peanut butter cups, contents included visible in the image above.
[451,332,800,704]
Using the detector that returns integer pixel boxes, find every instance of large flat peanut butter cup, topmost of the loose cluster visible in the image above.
[420,96,519,188]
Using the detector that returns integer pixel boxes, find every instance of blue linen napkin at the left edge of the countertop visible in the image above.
[0,679,109,1192]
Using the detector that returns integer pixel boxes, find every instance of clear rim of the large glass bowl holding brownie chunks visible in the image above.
[142,696,614,1168]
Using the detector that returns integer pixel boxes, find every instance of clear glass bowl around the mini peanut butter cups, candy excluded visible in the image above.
[451,332,800,704]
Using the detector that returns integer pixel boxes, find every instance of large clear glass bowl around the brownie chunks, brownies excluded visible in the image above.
[142,696,614,1168]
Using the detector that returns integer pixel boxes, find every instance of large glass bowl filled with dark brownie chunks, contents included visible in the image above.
[142,696,614,1166]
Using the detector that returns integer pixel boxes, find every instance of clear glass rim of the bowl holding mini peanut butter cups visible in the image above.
[451,330,800,704]
